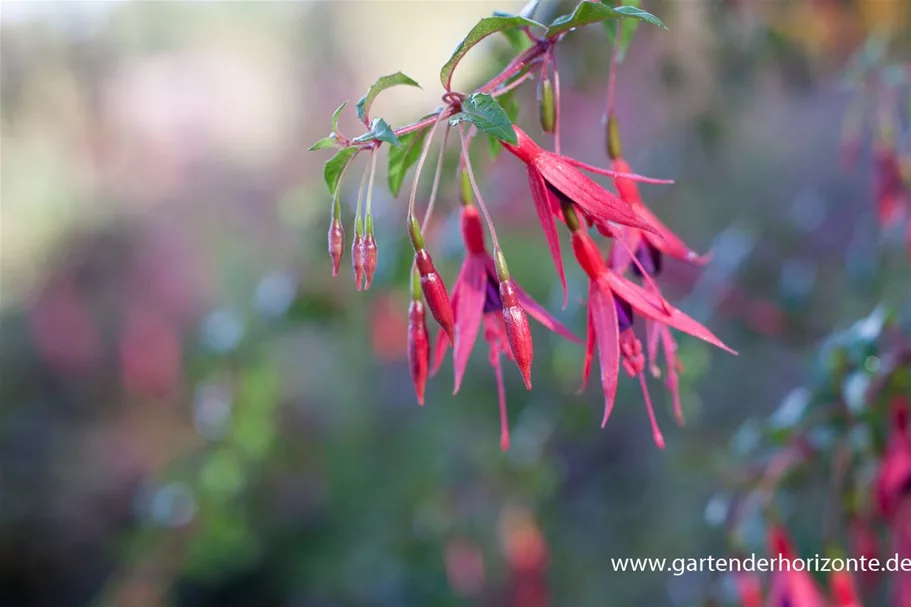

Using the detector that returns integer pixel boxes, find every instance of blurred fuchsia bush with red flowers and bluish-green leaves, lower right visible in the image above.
[713,309,911,607]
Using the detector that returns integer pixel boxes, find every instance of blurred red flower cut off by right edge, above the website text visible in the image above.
[876,399,911,520]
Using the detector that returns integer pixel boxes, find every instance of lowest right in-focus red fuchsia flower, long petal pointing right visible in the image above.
[564,206,736,448]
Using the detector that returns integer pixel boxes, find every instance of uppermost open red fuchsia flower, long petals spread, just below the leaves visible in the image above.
[503,125,671,305]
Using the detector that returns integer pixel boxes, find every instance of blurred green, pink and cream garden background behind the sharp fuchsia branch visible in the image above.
[0,0,911,607]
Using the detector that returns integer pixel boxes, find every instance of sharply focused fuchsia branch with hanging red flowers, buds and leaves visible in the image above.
[314,2,731,450]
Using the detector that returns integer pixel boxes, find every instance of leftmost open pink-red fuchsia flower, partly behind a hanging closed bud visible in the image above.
[431,201,579,450]
